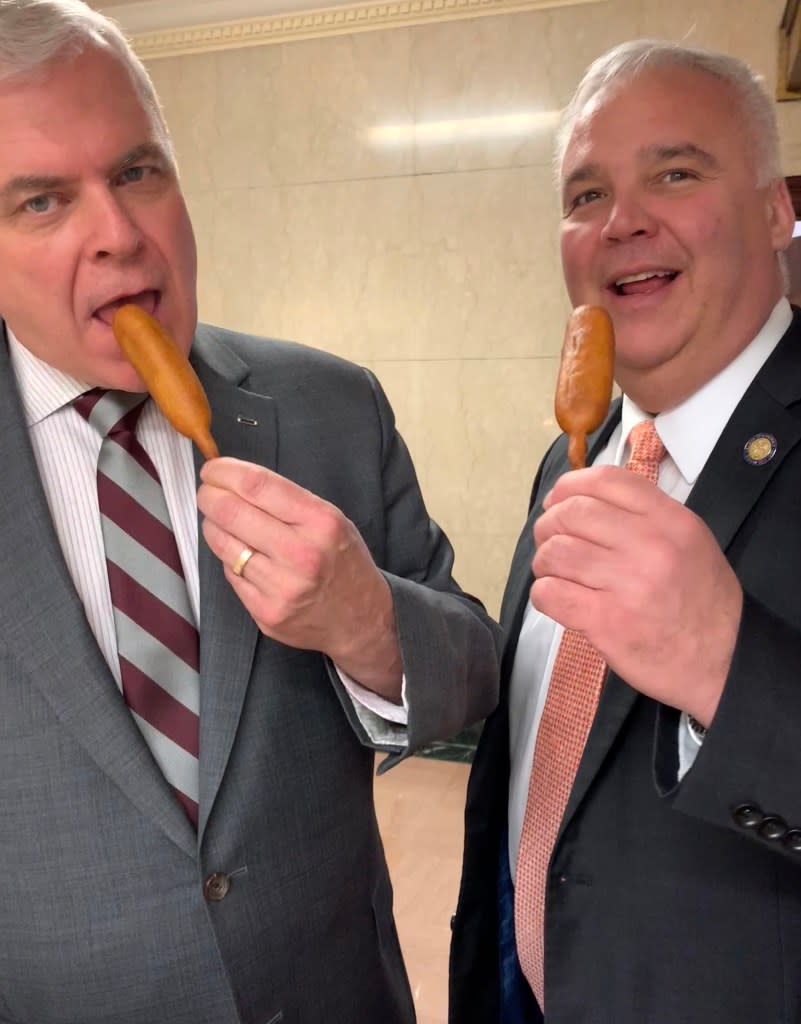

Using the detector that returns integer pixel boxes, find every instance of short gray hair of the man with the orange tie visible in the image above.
[555,39,782,187]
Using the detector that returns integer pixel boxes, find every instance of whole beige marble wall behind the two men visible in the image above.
[150,0,801,613]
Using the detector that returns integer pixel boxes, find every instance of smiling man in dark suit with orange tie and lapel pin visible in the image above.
[451,40,801,1024]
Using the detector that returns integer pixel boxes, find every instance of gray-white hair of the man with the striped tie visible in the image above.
[0,0,175,162]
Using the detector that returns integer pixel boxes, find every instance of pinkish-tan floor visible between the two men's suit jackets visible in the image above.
[375,757,470,1024]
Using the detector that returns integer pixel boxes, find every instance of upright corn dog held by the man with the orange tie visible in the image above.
[554,306,615,469]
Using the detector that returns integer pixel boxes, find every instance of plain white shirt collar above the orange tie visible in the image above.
[616,297,793,484]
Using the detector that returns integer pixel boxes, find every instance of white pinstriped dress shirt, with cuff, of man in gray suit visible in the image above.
[8,330,407,745]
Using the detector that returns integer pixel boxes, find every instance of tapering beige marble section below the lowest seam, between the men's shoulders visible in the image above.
[372,357,558,613]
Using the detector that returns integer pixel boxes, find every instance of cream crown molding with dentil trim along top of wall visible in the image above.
[122,0,607,60]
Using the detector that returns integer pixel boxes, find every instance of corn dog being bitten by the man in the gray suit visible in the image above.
[112,304,219,459]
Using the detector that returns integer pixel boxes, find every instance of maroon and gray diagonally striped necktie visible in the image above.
[75,388,200,826]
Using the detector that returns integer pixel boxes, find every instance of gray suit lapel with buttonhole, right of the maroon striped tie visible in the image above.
[193,328,278,837]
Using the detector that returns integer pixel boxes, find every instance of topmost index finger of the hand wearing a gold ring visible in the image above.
[201,458,325,524]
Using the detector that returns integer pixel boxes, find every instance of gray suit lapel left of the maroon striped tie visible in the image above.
[0,333,197,856]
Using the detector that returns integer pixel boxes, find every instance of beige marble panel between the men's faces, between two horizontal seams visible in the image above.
[189,168,567,361]
